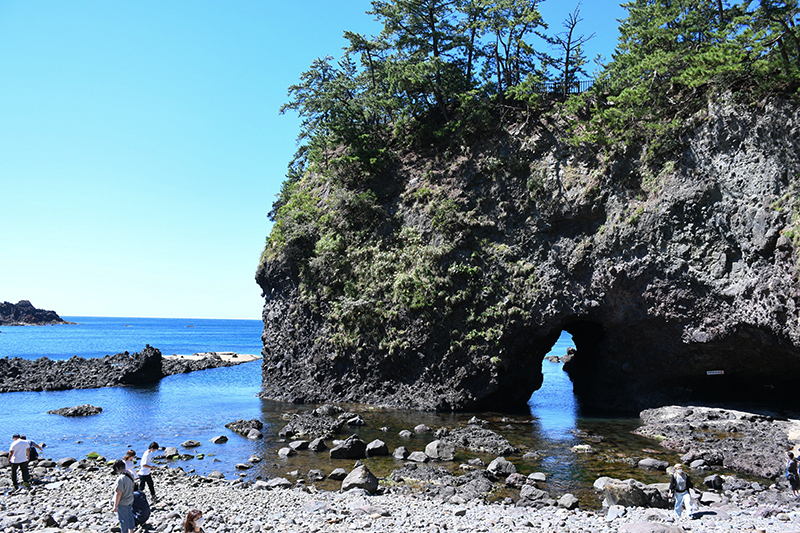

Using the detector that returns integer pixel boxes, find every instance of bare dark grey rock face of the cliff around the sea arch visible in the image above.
[256,95,800,412]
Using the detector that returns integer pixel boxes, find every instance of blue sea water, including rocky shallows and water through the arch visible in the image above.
[0,316,677,507]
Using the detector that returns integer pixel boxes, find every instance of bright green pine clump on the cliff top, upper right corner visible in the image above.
[576,0,800,155]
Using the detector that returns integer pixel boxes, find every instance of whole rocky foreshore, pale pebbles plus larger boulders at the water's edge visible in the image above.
[0,405,800,533]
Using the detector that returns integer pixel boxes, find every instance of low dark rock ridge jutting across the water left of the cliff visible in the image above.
[0,345,255,393]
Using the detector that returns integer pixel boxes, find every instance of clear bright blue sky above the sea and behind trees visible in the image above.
[0,0,624,319]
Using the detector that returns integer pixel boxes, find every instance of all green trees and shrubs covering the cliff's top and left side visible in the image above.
[262,0,800,365]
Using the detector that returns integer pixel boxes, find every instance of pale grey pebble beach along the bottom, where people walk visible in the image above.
[0,460,800,533]
